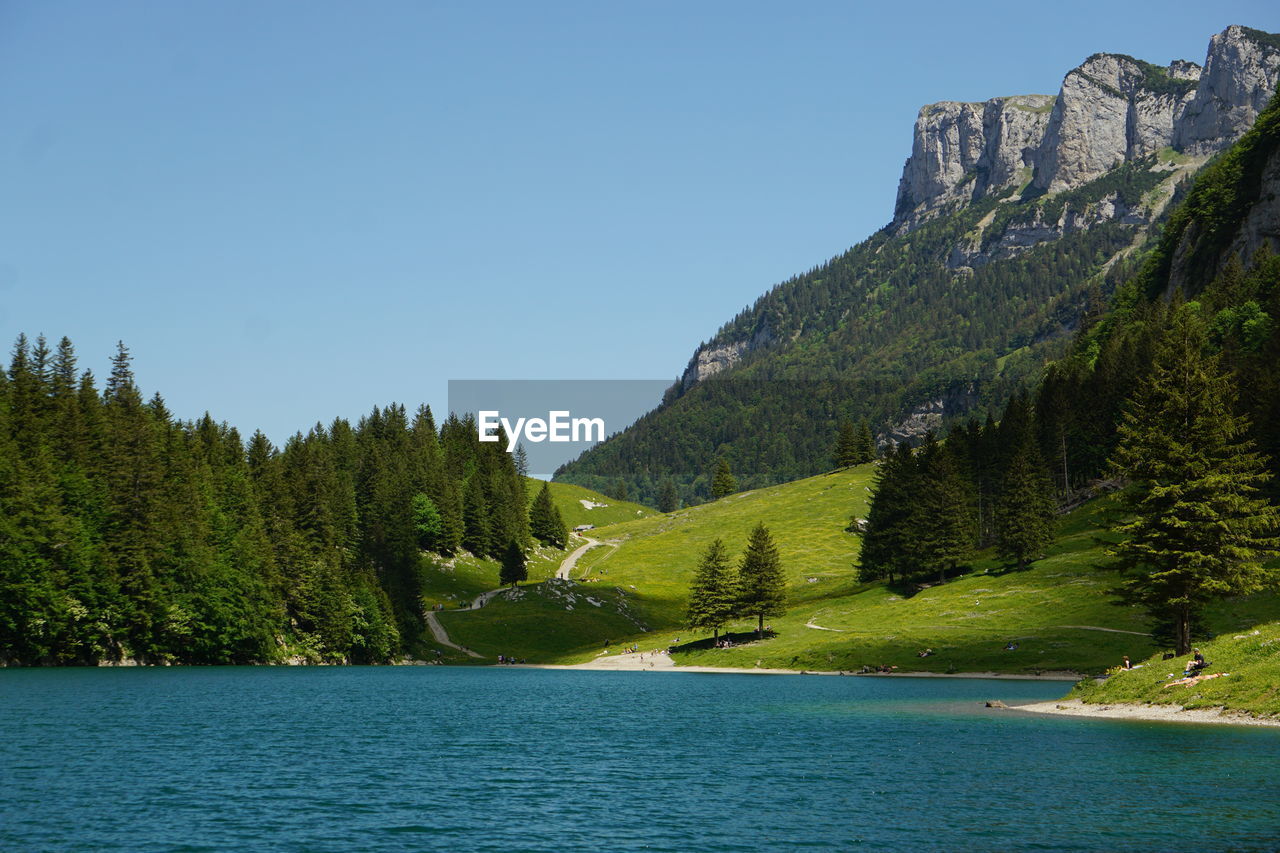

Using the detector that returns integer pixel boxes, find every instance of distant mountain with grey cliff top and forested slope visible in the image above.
[557,27,1280,502]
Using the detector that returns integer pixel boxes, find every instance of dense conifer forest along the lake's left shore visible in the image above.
[0,337,530,665]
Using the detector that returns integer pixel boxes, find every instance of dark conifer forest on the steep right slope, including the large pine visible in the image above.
[860,89,1280,652]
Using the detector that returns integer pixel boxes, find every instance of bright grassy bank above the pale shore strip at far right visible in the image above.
[1070,622,1280,715]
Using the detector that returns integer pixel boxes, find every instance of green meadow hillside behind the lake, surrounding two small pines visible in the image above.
[437,466,1280,672]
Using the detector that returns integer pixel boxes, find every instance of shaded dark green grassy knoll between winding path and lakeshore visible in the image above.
[438,580,644,663]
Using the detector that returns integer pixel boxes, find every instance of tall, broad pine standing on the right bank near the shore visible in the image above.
[1112,304,1280,654]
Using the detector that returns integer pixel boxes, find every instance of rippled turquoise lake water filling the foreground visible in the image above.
[0,667,1280,853]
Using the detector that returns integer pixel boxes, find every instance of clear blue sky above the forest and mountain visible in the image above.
[0,0,1280,442]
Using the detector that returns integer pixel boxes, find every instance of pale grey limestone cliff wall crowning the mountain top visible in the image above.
[890,27,1280,233]
